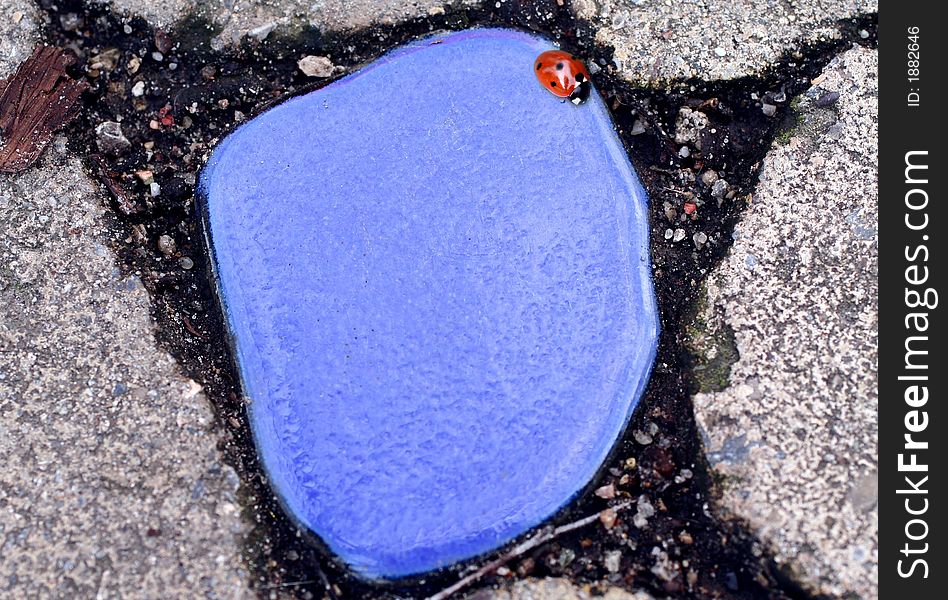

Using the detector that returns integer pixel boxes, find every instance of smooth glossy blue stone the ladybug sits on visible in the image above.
[201,29,658,578]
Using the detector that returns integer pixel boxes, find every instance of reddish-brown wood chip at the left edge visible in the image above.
[0,46,89,173]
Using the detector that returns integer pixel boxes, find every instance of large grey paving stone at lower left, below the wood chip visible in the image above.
[0,146,248,598]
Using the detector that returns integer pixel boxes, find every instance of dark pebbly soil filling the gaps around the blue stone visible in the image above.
[41,0,875,598]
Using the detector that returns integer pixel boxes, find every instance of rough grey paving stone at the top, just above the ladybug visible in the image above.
[572,0,878,84]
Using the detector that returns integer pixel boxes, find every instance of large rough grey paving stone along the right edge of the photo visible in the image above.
[692,48,878,598]
